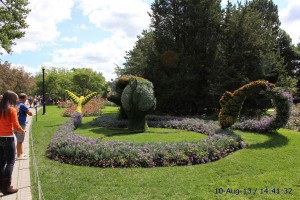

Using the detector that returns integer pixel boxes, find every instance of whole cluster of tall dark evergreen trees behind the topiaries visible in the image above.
[124,0,299,114]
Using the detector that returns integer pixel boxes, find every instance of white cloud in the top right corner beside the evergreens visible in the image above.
[279,0,300,44]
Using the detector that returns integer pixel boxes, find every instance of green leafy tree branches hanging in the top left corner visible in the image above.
[0,0,30,54]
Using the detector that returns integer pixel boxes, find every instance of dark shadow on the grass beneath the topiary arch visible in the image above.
[247,131,289,149]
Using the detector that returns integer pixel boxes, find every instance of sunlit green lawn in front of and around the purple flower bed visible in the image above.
[31,106,300,200]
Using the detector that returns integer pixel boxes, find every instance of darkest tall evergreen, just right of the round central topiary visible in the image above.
[146,0,221,114]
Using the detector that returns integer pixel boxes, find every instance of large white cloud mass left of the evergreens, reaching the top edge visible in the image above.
[52,0,150,80]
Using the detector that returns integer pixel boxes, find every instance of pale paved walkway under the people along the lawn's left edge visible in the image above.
[0,108,35,200]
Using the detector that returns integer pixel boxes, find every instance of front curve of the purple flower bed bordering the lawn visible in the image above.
[47,116,244,167]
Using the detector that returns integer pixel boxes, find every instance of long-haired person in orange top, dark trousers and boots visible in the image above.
[0,90,25,195]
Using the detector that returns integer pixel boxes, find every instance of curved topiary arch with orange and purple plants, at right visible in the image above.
[219,81,291,130]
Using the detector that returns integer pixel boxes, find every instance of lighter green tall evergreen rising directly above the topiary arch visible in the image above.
[210,0,284,104]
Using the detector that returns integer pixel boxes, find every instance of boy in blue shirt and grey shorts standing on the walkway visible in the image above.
[14,93,32,160]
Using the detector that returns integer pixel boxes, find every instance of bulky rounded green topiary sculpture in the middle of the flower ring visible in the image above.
[108,76,156,132]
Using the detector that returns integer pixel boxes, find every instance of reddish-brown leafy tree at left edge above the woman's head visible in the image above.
[0,62,35,95]
